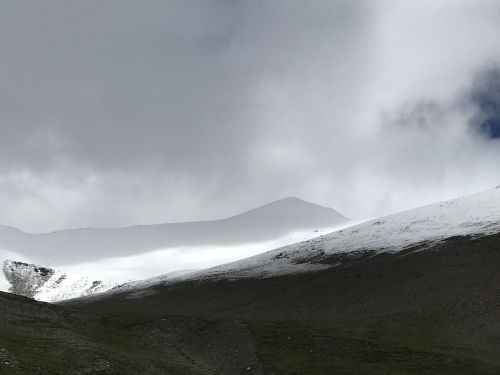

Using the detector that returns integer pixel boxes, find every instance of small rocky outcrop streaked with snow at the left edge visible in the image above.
[2,260,116,302]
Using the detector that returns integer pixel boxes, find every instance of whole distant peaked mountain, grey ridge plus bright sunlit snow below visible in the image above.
[0,198,350,298]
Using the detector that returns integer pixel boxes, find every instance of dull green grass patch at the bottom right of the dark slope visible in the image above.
[247,315,500,375]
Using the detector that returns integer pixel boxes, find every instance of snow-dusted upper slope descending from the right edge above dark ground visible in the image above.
[115,187,500,292]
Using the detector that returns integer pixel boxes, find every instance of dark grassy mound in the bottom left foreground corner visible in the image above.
[0,293,211,375]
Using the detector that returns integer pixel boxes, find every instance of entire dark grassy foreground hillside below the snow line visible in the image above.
[0,235,500,374]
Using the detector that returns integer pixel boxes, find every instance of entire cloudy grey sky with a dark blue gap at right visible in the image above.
[0,0,500,232]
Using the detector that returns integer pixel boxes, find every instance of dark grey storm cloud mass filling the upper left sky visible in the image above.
[0,1,368,174]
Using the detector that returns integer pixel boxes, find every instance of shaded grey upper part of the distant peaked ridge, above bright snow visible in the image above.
[0,199,348,264]
